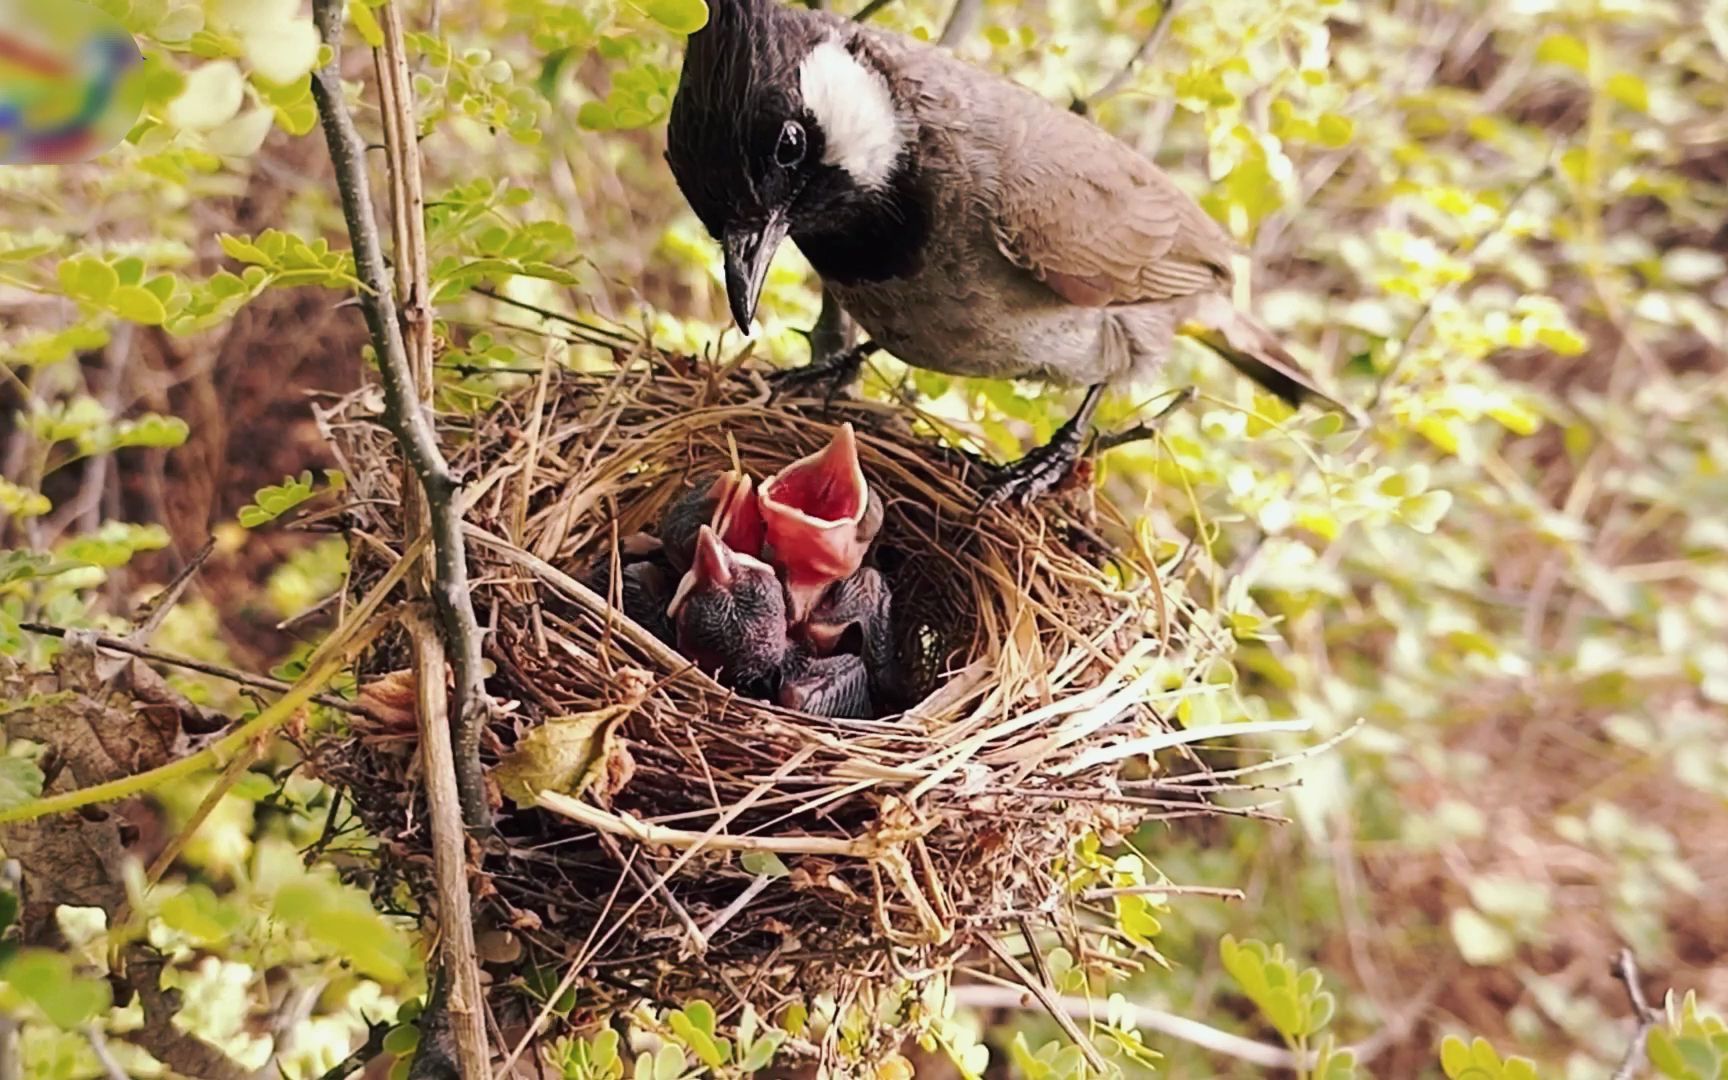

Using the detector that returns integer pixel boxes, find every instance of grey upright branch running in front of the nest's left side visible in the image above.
[313,0,491,829]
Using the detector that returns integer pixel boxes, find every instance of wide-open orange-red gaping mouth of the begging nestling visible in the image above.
[759,423,883,624]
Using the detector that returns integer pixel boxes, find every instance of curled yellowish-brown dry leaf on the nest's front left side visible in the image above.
[492,702,636,807]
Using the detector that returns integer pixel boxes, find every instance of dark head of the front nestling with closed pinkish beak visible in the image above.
[667,525,788,696]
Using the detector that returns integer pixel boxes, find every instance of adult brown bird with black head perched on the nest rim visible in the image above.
[667,0,1344,501]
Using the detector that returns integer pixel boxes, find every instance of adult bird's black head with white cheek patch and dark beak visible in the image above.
[667,0,911,334]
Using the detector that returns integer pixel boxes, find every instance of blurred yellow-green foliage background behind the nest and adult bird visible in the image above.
[0,0,1728,1080]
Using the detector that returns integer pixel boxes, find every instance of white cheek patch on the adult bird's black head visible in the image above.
[798,38,905,188]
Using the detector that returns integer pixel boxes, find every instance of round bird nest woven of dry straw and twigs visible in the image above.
[311,358,1251,1064]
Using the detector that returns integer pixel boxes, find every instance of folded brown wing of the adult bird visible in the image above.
[994,102,1236,308]
